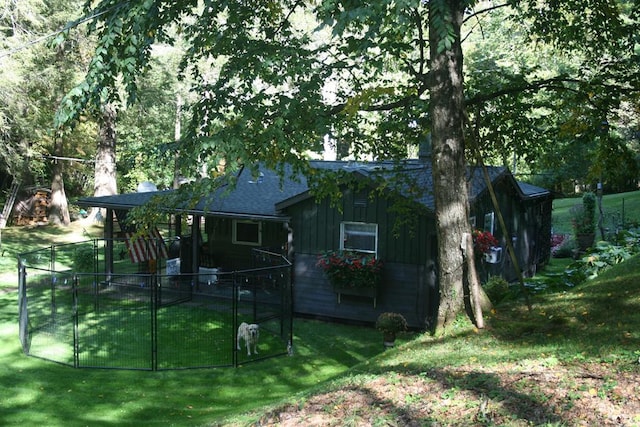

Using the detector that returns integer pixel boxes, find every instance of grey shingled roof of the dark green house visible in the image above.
[77,160,549,220]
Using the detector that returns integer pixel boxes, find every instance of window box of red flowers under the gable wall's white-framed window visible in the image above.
[316,251,382,304]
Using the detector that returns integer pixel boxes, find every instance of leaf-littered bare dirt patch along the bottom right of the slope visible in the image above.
[250,362,640,426]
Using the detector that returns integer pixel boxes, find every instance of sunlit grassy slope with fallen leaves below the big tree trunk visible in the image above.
[234,256,640,426]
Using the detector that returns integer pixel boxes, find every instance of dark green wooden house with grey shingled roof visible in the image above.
[80,158,552,328]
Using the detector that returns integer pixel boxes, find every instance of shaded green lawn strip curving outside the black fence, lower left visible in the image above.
[0,287,398,426]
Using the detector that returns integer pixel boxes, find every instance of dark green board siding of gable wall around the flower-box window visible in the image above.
[287,191,437,328]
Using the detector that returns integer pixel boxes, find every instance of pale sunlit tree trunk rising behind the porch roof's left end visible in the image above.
[90,104,118,220]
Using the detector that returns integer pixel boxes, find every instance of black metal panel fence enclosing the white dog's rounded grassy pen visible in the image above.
[18,240,293,370]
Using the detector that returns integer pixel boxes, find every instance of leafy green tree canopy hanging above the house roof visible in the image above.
[58,0,639,189]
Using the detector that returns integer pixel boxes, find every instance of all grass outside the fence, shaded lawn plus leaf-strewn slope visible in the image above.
[0,212,640,426]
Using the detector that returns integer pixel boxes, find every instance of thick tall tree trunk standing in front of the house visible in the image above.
[429,1,477,335]
